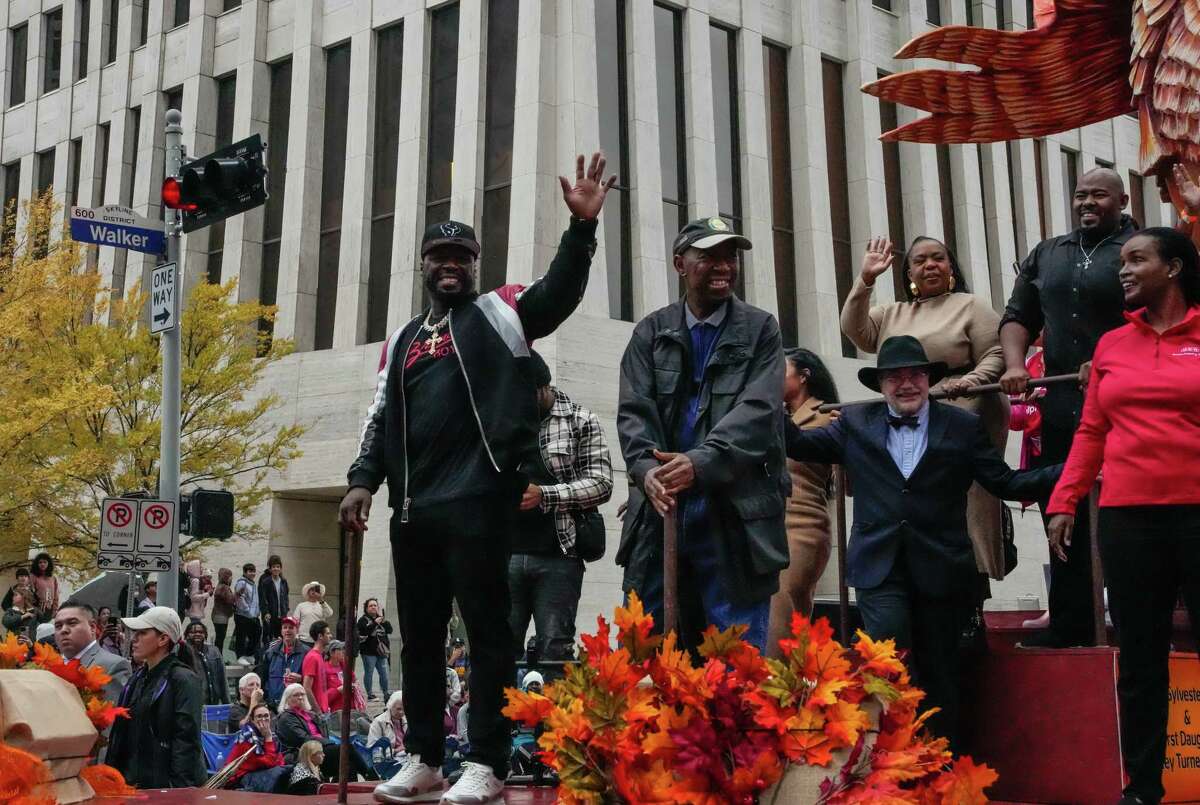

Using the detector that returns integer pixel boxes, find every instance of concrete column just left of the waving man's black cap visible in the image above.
[388,10,430,331]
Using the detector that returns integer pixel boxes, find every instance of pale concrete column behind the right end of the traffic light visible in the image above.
[220,0,271,301]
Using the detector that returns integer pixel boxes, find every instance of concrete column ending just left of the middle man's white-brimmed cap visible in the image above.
[626,0,674,322]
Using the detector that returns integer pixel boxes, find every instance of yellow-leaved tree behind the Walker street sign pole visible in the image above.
[0,193,305,571]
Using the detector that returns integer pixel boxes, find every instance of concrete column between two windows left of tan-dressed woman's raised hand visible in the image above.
[787,4,841,355]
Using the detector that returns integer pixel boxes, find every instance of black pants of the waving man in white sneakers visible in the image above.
[391,497,516,780]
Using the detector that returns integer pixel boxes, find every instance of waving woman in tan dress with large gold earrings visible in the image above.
[841,238,1008,579]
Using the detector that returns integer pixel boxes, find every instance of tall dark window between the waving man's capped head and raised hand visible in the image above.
[479,0,517,290]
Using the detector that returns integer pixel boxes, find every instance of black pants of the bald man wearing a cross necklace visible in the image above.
[1038,425,1096,645]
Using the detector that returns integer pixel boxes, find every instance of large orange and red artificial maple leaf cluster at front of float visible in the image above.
[504,594,997,805]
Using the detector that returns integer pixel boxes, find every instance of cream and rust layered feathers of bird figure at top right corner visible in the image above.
[1129,0,1200,172]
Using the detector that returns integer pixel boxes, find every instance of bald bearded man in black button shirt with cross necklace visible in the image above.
[1000,168,1138,648]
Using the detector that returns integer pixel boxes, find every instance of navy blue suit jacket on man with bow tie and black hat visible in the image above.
[787,401,1062,597]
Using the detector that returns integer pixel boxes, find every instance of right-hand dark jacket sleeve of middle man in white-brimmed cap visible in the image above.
[688,317,784,489]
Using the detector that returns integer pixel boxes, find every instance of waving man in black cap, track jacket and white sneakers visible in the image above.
[340,154,614,803]
